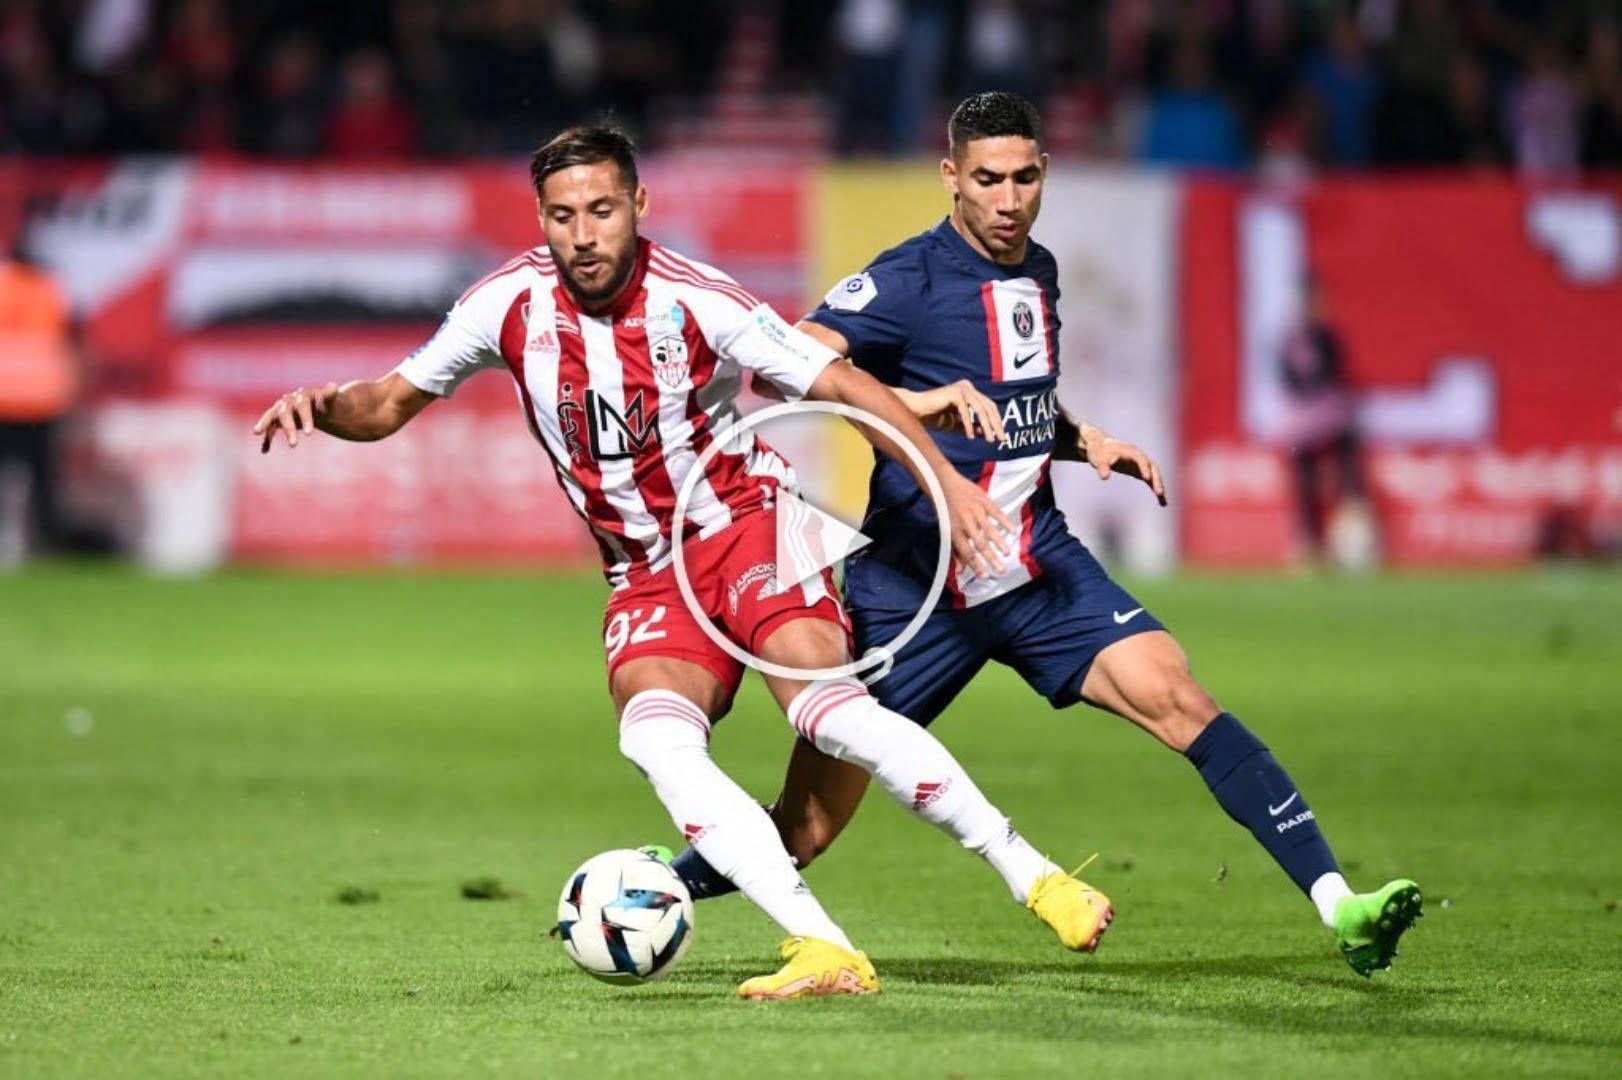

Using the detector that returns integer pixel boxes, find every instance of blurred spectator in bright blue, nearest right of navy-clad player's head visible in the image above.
[1142,37,1244,169]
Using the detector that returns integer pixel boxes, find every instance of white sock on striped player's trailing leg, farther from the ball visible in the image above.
[788,678,1056,903]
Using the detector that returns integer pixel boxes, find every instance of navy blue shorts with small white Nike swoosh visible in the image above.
[845,535,1165,726]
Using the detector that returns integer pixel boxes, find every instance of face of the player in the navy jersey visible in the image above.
[941,135,1048,263]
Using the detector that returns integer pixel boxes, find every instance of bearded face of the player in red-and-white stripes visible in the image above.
[535,161,647,308]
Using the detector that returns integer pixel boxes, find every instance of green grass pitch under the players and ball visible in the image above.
[0,566,1622,1078]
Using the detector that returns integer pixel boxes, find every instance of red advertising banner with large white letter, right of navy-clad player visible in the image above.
[1181,177,1622,564]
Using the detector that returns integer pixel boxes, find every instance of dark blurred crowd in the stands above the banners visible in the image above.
[0,0,1622,175]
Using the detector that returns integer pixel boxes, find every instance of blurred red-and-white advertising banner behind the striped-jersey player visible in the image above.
[0,159,809,561]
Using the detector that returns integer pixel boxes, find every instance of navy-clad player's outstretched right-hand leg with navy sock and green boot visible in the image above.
[1080,631,1421,975]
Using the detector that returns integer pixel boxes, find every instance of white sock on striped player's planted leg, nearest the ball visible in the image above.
[620,689,855,949]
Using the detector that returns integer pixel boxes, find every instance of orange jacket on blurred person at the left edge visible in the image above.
[0,263,79,422]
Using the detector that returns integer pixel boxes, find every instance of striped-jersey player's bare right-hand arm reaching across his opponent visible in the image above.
[806,358,1017,576]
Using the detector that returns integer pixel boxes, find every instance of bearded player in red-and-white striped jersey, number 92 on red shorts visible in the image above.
[255,126,1102,997]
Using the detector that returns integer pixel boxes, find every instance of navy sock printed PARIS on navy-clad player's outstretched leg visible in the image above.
[1186,712,1340,892]
